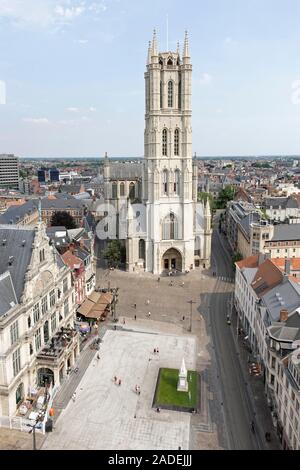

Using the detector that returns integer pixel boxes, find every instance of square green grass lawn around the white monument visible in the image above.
[154,369,198,411]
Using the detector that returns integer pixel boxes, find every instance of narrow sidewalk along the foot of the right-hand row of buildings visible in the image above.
[231,314,281,450]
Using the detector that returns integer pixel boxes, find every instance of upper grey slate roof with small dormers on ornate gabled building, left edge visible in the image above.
[0,225,35,302]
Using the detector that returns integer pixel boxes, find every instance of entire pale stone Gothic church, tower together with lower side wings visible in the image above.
[104,33,212,274]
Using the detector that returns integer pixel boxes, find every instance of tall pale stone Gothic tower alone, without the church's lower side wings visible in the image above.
[143,31,197,274]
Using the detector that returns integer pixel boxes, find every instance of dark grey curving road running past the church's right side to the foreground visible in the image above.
[208,224,261,450]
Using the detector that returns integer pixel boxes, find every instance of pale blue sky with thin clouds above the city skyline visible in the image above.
[0,0,300,157]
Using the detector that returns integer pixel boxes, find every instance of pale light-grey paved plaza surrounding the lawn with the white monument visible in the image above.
[43,321,196,450]
